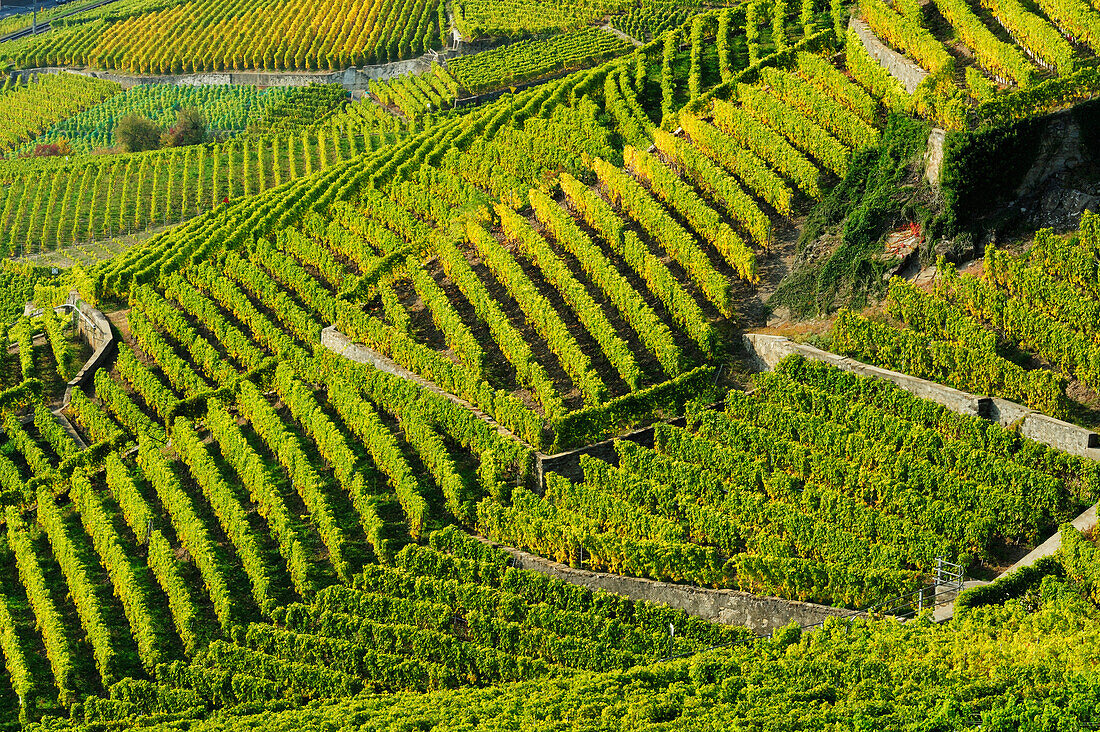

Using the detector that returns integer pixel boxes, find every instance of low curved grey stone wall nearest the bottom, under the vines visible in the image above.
[494,544,860,635]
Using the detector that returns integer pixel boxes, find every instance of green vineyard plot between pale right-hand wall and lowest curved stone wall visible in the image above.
[477,360,1100,607]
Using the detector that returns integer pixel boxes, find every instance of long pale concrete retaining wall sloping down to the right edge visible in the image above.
[745,334,1100,460]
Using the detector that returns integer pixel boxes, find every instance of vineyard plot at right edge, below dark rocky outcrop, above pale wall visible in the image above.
[834,214,1100,419]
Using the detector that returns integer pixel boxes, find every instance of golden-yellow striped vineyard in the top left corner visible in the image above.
[0,0,446,74]
